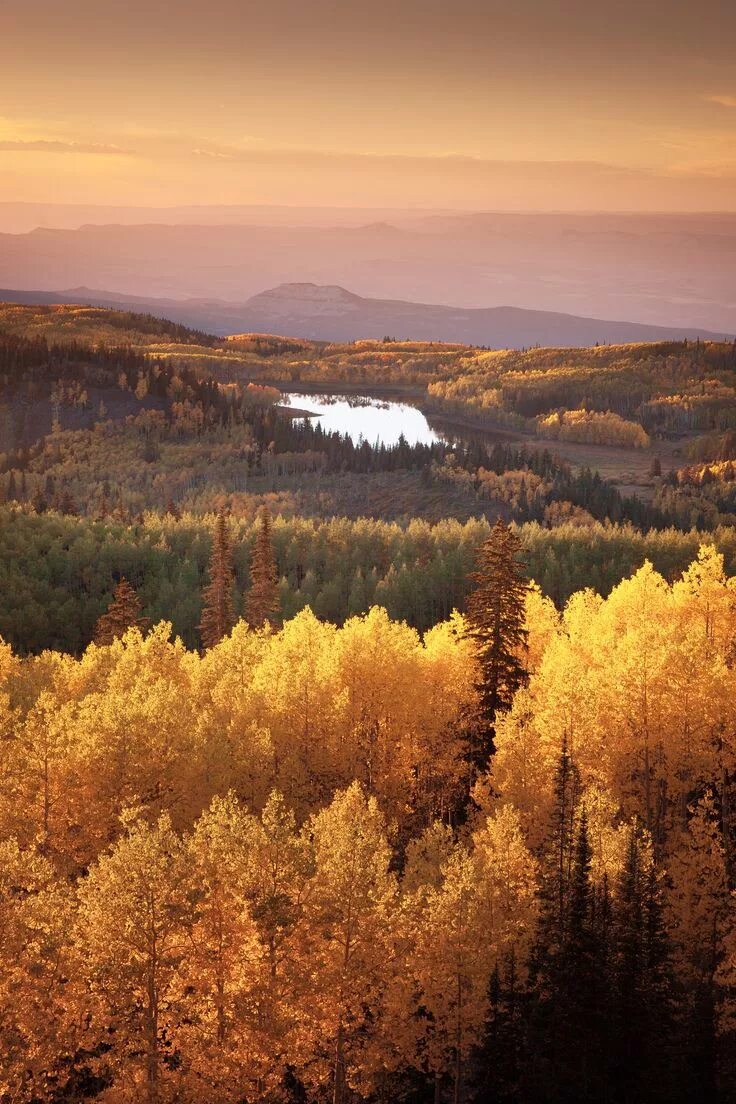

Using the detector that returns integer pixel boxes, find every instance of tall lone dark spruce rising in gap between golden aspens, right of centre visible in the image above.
[467,519,529,766]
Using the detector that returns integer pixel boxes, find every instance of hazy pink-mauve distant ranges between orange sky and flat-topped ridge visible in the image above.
[0,206,736,333]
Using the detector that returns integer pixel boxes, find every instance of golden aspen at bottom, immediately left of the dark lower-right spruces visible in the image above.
[403,808,537,1093]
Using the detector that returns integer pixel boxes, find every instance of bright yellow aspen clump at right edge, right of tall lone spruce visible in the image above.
[492,549,734,872]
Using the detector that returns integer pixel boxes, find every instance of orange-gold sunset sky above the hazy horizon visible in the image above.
[0,0,736,211]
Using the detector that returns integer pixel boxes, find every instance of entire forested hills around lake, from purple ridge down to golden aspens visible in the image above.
[0,306,736,654]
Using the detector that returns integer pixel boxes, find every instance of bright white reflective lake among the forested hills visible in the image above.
[281,392,444,446]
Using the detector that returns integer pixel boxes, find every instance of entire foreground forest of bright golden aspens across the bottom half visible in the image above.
[0,546,736,1104]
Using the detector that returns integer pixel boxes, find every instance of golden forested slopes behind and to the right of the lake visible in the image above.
[228,338,736,445]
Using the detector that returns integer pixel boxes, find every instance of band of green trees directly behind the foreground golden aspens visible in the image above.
[0,506,736,654]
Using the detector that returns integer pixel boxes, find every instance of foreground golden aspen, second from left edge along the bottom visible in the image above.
[75,815,192,1104]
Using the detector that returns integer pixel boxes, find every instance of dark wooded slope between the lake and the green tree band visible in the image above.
[0,393,679,528]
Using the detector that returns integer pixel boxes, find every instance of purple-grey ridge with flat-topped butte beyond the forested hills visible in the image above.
[0,283,729,349]
